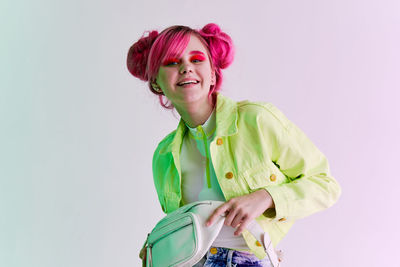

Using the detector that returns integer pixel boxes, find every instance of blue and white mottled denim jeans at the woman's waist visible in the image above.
[193,247,272,267]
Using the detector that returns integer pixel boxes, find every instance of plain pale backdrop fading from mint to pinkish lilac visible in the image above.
[0,0,400,267]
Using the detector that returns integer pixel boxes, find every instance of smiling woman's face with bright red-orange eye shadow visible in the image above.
[153,35,215,110]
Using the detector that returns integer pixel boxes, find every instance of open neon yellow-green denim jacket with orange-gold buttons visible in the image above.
[153,93,341,258]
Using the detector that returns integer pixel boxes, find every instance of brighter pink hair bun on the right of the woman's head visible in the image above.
[199,23,234,69]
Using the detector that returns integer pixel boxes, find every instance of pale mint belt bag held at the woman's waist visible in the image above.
[144,200,224,267]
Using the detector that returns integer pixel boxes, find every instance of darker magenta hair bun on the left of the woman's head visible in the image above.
[126,31,158,81]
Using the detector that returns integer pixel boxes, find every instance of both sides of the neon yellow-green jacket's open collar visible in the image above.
[160,92,238,157]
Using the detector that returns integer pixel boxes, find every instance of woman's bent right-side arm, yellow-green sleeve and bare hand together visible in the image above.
[208,104,340,234]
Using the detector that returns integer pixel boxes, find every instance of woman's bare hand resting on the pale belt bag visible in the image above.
[206,189,275,235]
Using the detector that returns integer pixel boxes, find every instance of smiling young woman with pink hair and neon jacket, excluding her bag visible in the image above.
[127,24,340,267]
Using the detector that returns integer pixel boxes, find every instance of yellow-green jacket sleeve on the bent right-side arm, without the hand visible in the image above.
[260,103,341,221]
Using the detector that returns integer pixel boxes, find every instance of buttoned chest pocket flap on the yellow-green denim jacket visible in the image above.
[241,162,286,191]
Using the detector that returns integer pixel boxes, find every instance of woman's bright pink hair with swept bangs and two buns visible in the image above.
[127,23,234,108]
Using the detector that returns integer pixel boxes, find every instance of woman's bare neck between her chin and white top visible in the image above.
[175,95,216,128]
